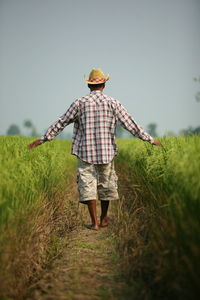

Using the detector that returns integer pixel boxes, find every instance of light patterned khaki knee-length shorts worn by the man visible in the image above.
[77,159,119,202]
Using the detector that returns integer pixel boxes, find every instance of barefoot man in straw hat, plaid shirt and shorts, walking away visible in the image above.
[28,69,161,230]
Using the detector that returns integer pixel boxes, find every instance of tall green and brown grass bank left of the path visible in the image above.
[0,137,77,299]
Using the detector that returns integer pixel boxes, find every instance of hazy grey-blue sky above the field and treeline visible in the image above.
[0,0,200,135]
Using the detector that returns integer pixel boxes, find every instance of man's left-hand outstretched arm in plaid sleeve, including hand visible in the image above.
[28,100,78,149]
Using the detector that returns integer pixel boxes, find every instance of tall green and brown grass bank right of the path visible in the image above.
[116,136,200,299]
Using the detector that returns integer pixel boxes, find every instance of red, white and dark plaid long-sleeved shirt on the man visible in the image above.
[40,90,153,164]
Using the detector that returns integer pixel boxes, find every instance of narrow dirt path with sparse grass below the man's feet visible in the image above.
[26,205,124,300]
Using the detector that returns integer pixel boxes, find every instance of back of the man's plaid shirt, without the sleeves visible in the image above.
[73,90,117,164]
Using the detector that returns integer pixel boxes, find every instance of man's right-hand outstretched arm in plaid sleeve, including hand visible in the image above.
[116,101,161,146]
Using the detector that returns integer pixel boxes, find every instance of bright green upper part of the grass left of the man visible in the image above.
[0,137,76,225]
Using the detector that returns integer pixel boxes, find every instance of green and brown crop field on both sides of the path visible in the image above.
[0,136,200,300]
